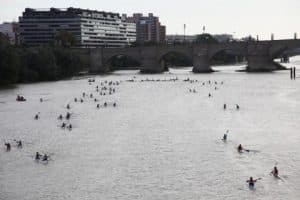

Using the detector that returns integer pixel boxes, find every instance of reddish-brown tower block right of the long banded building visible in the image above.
[127,13,166,44]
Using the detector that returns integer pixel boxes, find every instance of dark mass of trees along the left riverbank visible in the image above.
[0,35,83,85]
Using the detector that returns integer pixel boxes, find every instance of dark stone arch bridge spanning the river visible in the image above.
[89,39,300,73]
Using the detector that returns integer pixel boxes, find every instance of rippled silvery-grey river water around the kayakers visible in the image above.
[0,59,300,200]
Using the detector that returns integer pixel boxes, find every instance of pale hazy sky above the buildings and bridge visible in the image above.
[0,0,300,39]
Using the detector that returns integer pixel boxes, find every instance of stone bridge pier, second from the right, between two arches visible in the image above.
[193,48,213,73]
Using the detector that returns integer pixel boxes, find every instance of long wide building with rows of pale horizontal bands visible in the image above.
[19,8,136,47]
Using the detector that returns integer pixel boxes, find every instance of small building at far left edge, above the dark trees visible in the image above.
[0,22,19,44]
